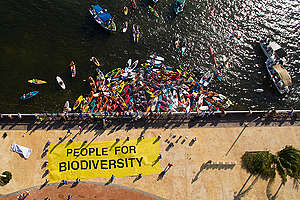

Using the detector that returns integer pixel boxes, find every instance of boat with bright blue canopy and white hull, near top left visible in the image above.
[89,4,117,32]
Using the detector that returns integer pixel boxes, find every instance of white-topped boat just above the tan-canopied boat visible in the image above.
[259,39,287,62]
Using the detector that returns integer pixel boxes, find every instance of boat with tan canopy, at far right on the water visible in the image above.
[266,57,292,95]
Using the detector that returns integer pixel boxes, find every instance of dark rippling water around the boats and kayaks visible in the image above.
[0,0,300,113]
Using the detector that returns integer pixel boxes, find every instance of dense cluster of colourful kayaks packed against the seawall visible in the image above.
[73,54,232,114]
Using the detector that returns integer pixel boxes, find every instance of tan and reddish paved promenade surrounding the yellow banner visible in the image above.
[0,126,300,200]
